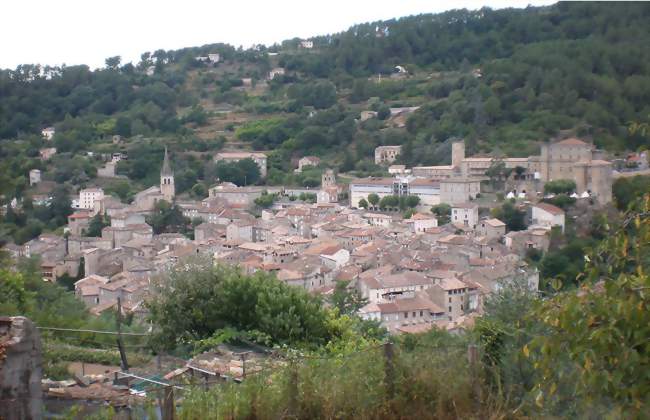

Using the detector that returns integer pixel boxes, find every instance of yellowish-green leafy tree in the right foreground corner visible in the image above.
[524,195,650,418]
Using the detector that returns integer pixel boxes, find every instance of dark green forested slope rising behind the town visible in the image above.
[0,3,650,246]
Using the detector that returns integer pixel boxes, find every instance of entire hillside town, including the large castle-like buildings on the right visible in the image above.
[2,138,612,333]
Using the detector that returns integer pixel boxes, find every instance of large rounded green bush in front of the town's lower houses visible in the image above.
[149,261,332,348]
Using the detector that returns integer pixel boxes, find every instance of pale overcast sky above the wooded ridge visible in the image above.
[0,0,554,68]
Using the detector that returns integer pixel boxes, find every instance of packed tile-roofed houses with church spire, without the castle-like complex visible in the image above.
[14,149,564,332]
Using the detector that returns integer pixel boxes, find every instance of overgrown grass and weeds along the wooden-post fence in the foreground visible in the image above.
[178,332,496,419]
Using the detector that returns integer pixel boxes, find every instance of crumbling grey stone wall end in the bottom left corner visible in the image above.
[0,316,43,420]
